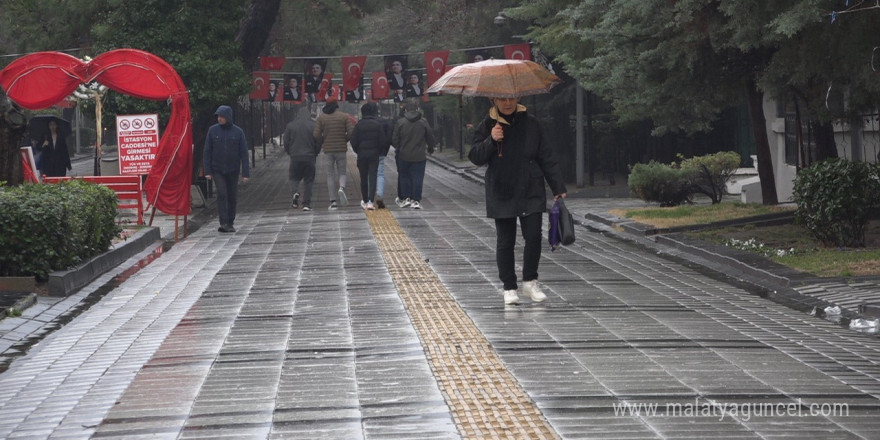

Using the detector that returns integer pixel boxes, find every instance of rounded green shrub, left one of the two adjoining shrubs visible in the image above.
[627,161,693,206]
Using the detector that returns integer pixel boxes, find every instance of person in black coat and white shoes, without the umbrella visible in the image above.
[468,98,566,304]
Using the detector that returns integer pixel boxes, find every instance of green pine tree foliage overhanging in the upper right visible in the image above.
[508,0,880,132]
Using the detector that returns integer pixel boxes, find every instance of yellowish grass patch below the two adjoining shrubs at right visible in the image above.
[611,202,794,228]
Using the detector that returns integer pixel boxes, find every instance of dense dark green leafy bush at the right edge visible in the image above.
[793,159,880,247]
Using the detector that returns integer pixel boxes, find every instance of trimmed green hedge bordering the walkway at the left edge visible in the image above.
[0,179,120,279]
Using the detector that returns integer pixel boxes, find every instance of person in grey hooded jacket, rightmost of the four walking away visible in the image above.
[391,99,434,209]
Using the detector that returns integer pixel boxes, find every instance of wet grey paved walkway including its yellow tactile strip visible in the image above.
[0,144,880,439]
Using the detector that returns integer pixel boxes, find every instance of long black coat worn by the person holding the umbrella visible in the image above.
[468,107,566,218]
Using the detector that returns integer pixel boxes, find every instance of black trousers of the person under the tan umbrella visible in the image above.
[495,212,543,290]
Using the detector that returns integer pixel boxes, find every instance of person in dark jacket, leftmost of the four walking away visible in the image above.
[282,107,321,211]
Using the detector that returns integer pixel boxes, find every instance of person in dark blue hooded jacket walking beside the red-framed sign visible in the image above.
[203,105,250,232]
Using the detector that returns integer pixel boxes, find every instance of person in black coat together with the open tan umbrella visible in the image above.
[428,60,566,305]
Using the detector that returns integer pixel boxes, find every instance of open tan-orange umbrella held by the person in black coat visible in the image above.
[428,59,562,98]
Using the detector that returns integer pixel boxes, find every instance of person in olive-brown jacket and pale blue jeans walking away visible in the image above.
[313,96,354,210]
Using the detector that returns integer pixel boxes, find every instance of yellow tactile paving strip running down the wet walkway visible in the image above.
[367,209,559,439]
